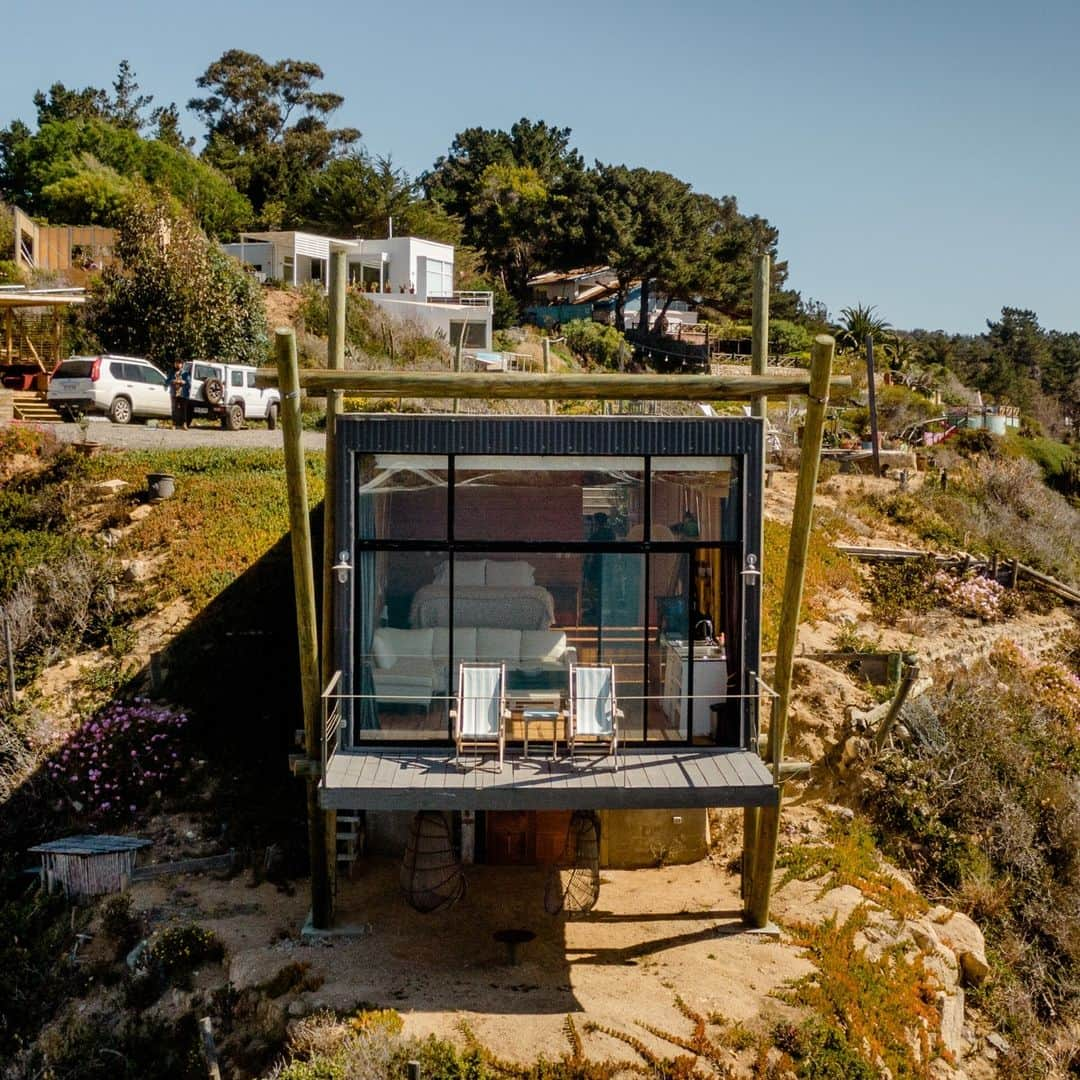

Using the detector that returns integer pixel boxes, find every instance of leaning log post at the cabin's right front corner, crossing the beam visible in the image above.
[748,334,835,928]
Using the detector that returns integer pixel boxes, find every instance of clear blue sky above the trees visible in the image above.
[0,0,1080,332]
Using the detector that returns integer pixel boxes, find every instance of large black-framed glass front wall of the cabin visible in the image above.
[352,454,743,745]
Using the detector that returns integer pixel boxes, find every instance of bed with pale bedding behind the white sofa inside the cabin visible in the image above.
[409,559,555,630]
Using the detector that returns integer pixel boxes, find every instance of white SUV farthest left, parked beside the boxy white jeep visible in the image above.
[46,355,172,423]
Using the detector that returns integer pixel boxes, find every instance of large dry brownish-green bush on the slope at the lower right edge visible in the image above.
[866,643,1080,1077]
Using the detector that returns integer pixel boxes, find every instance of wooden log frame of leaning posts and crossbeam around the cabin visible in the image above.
[267,336,852,929]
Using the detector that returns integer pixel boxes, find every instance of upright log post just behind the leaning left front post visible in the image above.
[320,245,349,919]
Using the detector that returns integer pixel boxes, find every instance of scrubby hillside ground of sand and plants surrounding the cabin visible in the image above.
[0,425,1080,1080]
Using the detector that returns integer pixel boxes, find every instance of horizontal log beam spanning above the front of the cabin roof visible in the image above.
[256,367,851,402]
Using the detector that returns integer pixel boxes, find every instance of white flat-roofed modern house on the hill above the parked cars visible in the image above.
[221,231,494,349]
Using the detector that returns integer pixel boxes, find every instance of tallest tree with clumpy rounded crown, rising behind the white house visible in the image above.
[188,49,360,226]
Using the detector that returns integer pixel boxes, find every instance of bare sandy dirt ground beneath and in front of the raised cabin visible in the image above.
[132,859,811,1061]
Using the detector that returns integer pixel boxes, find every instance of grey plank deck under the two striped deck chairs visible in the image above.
[319,747,780,810]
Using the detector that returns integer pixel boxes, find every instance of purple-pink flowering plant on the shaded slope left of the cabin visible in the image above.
[48,698,188,820]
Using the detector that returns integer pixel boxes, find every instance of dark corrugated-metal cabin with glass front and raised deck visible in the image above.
[318,415,780,889]
